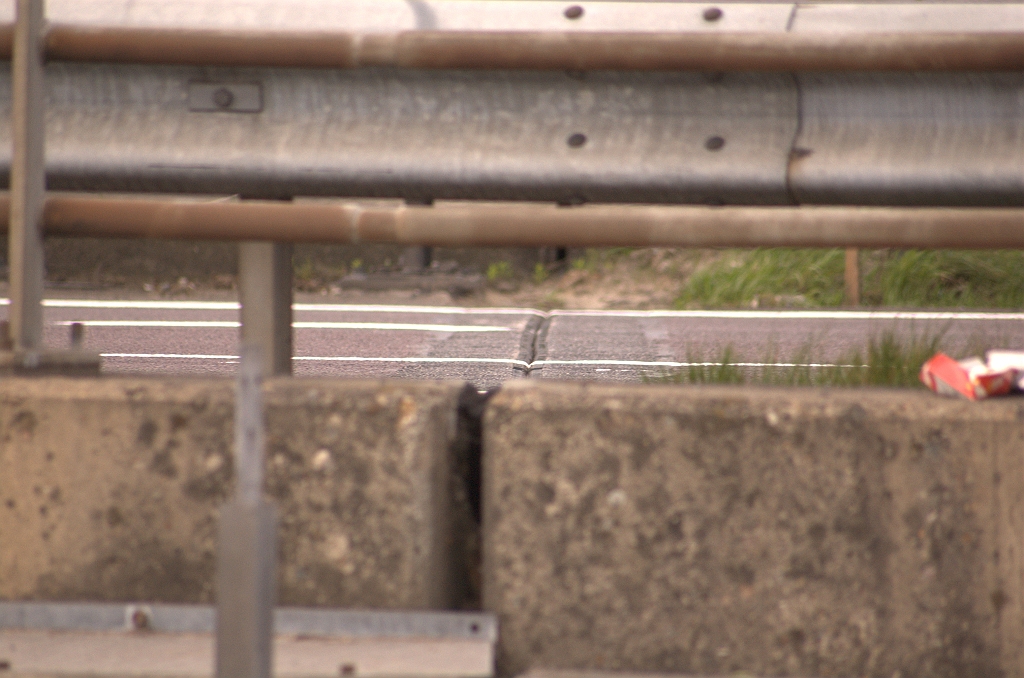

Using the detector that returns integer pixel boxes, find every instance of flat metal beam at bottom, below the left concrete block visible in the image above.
[0,602,497,678]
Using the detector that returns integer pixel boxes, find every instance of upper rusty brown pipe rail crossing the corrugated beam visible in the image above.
[0,24,1024,72]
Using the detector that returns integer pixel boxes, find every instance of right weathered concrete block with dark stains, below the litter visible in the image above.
[483,382,1024,678]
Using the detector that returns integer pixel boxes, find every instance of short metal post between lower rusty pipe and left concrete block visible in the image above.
[239,243,292,377]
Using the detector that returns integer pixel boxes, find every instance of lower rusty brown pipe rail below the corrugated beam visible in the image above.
[0,194,1024,249]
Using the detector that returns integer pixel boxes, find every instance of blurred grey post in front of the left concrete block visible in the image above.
[216,345,278,678]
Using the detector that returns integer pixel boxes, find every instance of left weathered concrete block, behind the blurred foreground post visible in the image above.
[0,378,475,608]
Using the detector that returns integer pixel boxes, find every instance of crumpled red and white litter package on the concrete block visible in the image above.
[921,350,1024,400]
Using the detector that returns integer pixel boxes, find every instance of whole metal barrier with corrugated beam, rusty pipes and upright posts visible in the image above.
[0,0,1024,676]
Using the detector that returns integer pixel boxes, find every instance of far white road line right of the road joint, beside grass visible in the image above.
[550,310,1024,321]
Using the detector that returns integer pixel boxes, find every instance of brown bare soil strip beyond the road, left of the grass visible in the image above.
[32,241,717,310]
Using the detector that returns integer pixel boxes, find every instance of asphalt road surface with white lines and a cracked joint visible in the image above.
[8,299,1024,389]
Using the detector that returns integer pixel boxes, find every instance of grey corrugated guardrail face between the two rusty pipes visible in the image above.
[0,69,1024,207]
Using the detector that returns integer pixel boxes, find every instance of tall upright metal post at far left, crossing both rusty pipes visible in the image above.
[7,0,46,351]
